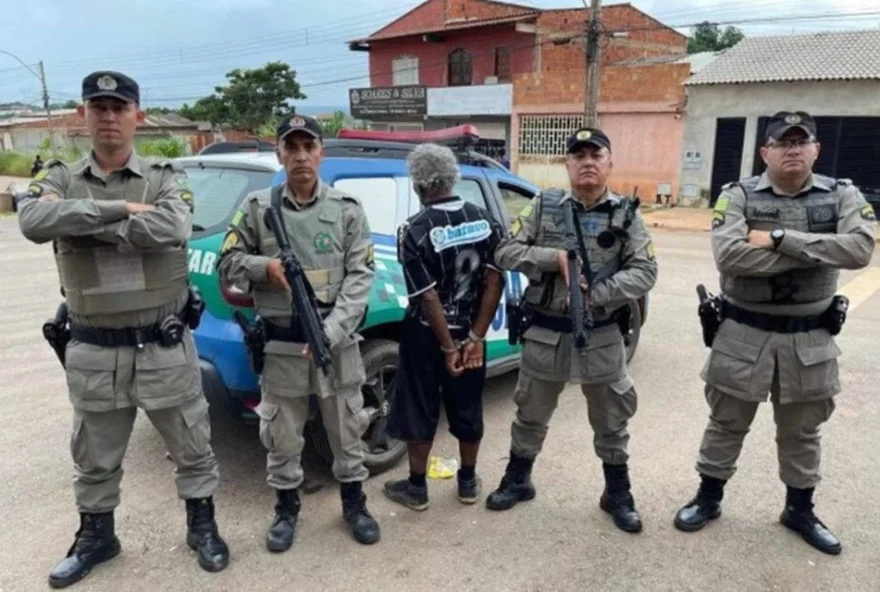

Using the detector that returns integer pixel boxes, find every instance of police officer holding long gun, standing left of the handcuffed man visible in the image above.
[218,116,379,552]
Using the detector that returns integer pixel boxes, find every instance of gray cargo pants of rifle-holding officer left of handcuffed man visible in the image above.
[257,340,369,489]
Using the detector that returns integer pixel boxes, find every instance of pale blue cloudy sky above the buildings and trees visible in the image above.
[0,0,880,107]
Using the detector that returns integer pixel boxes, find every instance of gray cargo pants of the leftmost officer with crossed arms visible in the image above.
[65,331,220,513]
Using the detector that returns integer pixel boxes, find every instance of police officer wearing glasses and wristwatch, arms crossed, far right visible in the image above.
[675,112,876,554]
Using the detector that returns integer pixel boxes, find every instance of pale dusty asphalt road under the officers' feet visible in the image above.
[0,217,880,592]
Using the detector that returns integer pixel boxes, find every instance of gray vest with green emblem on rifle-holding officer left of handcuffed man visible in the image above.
[253,186,345,319]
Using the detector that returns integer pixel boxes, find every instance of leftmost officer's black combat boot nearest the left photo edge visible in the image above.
[49,512,122,588]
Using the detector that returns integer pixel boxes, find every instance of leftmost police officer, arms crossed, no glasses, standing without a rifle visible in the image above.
[19,71,229,588]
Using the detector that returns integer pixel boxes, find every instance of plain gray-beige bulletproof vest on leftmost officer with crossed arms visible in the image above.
[55,155,188,315]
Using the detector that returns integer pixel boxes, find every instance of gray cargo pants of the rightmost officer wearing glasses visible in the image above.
[696,320,840,489]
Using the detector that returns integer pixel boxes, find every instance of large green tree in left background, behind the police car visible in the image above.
[180,62,306,134]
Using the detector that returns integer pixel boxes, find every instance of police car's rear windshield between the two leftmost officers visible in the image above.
[180,166,274,234]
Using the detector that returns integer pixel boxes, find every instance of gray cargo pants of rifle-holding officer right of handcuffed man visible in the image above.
[510,327,638,465]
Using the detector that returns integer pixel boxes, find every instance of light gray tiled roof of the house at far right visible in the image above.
[685,29,880,85]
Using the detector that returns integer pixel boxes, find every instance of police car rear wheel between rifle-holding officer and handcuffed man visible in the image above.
[306,339,406,475]
